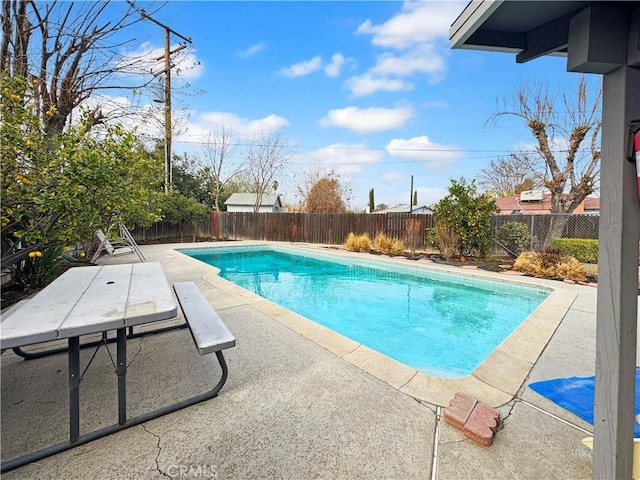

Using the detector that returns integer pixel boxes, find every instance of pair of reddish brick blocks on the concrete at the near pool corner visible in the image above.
[444,392,500,447]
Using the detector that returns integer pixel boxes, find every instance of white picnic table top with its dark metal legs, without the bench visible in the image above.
[0,262,178,472]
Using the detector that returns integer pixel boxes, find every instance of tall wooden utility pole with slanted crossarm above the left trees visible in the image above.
[127,0,193,193]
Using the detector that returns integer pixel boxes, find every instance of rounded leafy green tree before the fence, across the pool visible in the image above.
[433,177,498,256]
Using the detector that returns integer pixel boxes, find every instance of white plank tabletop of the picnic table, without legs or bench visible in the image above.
[0,263,177,349]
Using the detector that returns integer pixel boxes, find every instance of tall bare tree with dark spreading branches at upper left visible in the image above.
[0,0,165,135]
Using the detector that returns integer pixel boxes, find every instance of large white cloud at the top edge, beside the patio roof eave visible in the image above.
[356,1,467,49]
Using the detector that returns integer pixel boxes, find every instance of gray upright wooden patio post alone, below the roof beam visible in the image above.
[593,65,640,478]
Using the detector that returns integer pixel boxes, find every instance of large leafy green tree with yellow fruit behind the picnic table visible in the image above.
[0,74,163,267]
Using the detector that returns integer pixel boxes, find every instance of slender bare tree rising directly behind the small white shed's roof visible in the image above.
[246,130,292,212]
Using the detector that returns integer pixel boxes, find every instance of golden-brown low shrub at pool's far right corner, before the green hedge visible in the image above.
[513,247,587,282]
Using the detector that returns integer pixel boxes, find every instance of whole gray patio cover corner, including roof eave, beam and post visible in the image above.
[449,0,640,479]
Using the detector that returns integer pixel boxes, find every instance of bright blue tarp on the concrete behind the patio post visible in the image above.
[529,367,640,437]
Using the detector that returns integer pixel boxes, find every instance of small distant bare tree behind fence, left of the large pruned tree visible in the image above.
[477,154,544,197]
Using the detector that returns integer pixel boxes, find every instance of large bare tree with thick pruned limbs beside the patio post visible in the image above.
[493,75,602,244]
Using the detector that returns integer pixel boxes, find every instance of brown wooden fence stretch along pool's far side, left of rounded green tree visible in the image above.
[211,212,433,248]
